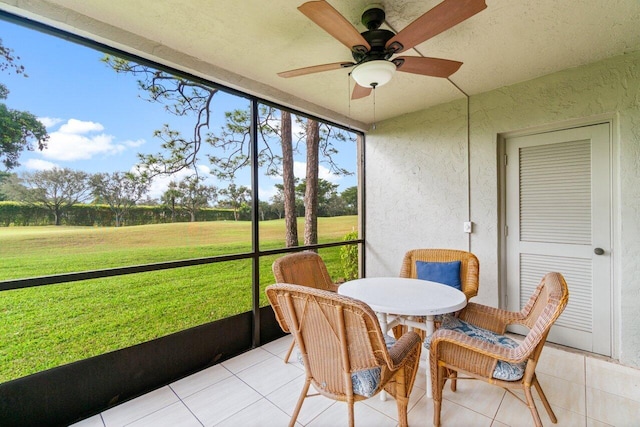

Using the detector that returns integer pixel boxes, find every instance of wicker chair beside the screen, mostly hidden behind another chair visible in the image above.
[271,251,338,363]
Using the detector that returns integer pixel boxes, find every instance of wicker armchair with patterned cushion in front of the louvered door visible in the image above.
[429,273,569,427]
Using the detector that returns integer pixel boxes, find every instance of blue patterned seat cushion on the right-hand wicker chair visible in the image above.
[424,316,527,381]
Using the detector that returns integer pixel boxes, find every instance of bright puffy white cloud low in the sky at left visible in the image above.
[42,119,126,161]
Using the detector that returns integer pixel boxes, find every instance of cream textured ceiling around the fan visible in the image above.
[0,0,640,128]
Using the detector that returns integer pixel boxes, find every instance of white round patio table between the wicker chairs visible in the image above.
[338,277,467,398]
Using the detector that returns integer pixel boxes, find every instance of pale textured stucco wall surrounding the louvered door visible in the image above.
[366,52,640,367]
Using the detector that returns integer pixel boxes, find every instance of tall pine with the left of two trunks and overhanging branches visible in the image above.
[103,56,350,241]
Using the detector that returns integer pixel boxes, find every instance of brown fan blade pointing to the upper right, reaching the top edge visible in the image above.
[386,0,487,53]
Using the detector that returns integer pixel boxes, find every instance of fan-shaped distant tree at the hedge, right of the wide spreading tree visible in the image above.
[90,172,150,227]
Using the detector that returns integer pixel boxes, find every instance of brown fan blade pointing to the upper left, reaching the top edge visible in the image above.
[298,0,371,52]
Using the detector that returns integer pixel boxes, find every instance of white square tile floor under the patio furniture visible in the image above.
[74,337,640,427]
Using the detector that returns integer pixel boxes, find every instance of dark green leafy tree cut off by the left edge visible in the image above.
[0,39,49,170]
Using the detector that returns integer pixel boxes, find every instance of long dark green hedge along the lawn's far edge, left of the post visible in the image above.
[0,201,234,227]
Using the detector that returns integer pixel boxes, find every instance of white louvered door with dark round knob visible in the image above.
[506,124,612,356]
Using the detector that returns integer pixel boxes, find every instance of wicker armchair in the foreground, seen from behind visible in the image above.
[266,283,421,426]
